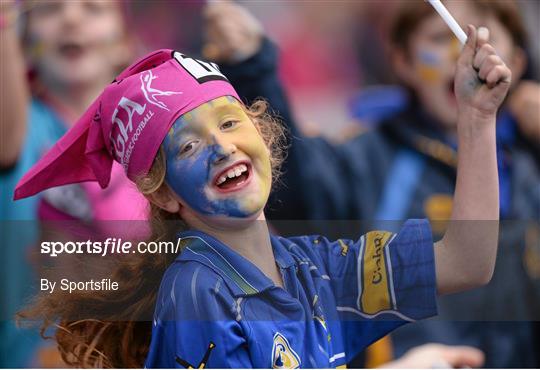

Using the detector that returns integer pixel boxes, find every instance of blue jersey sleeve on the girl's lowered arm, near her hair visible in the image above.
[145,263,253,368]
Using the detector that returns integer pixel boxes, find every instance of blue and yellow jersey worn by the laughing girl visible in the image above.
[145,220,436,368]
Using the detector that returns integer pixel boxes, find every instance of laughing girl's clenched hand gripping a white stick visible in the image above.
[454,25,512,117]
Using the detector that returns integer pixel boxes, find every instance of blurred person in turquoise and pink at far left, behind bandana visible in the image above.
[0,0,147,367]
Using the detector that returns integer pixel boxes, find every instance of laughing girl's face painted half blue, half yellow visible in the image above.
[163,96,272,218]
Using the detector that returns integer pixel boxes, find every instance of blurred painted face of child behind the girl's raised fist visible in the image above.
[397,1,521,130]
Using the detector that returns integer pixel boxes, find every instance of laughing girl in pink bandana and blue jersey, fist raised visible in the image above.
[15,26,510,368]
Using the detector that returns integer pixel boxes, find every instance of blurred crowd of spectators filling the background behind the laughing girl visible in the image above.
[0,0,540,368]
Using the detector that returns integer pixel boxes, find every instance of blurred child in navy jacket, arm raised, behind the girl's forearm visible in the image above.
[207,0,540,367]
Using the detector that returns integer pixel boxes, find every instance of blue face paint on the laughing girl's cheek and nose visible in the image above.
[164,117,249,217]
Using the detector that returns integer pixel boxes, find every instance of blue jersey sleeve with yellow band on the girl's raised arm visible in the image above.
[314,220,436,321]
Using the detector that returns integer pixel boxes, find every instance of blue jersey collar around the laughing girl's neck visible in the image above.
[176,230,294,297]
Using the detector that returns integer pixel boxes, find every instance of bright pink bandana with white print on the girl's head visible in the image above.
[14,49,240,199]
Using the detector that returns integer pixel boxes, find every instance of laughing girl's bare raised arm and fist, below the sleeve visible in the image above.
[435,26,511,294]
